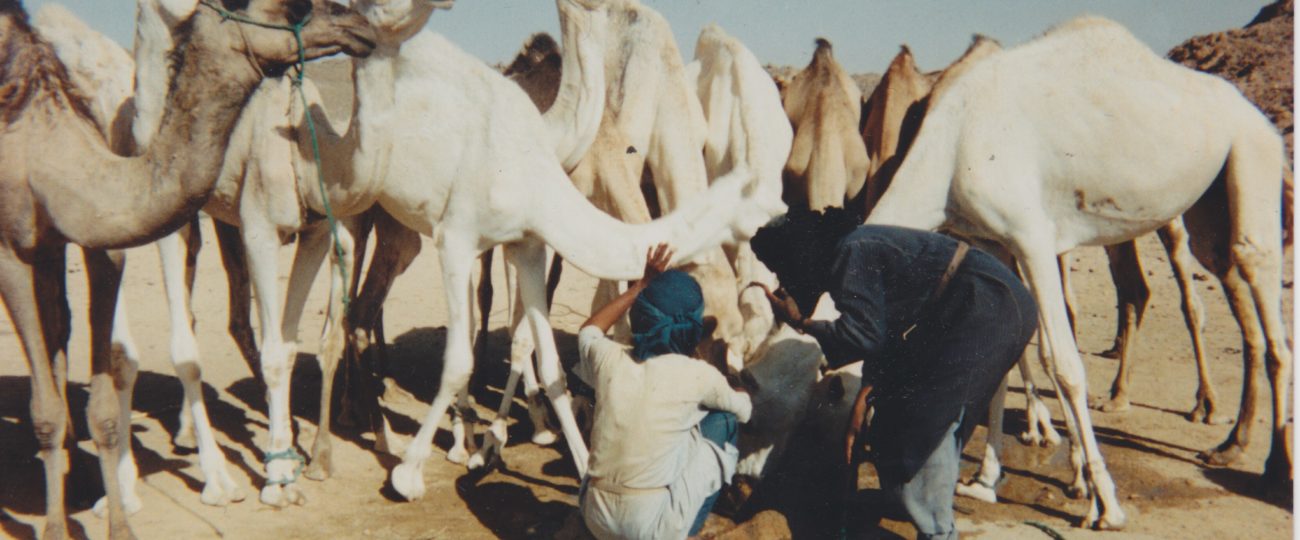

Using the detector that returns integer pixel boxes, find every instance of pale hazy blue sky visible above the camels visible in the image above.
[25,0,1268,73]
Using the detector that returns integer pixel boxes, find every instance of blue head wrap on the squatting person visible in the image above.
[628,271,705,360]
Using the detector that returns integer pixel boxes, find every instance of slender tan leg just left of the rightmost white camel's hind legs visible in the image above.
[1157,217,1230,424]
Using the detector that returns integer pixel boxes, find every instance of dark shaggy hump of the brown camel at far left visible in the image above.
[0,0,98,126]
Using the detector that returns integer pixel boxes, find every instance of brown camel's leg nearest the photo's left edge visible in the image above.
[0,246,71,539]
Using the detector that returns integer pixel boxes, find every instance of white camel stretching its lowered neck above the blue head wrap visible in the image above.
[317,0,768,498]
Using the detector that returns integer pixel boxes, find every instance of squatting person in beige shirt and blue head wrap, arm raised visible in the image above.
[577,245,750,539]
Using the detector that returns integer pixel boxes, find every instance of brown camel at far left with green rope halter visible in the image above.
[0,0,373,539]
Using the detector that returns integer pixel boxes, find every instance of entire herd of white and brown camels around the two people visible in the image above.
[0,0,1291,537]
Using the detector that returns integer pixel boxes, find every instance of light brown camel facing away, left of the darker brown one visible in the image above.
[781,38,870,209]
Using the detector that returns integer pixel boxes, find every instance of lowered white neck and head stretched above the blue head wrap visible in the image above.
[529,168,785,280]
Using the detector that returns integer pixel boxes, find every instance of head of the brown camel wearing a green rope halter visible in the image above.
[188,0,374,73]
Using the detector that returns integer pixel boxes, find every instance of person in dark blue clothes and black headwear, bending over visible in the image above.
[750,208,1037,539]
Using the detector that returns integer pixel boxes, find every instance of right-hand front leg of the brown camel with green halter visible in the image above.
[79,251,138,539]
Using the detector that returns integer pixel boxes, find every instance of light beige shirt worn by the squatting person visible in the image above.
[577,327,751,489]
